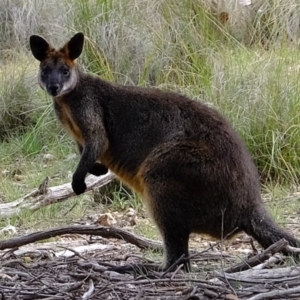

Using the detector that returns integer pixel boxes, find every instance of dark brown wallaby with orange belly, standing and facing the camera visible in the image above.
[30,33,299,269]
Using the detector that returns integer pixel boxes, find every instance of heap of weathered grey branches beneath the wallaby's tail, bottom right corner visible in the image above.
[216,239,300,300]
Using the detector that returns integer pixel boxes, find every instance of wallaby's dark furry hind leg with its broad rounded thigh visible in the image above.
[140,140,223,270]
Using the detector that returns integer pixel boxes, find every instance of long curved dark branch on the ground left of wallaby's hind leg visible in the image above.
[0,225,162,250]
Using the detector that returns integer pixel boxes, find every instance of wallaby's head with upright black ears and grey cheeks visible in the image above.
[29,32,84,97]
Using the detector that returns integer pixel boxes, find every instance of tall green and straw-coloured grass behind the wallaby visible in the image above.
[0,0,300,237]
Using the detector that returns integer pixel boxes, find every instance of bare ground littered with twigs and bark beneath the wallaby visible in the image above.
[0,204,300,300]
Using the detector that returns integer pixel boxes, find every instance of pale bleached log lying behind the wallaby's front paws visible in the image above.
[0,172,115,218]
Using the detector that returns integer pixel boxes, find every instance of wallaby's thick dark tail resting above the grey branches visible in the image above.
[244,207,300,254]
